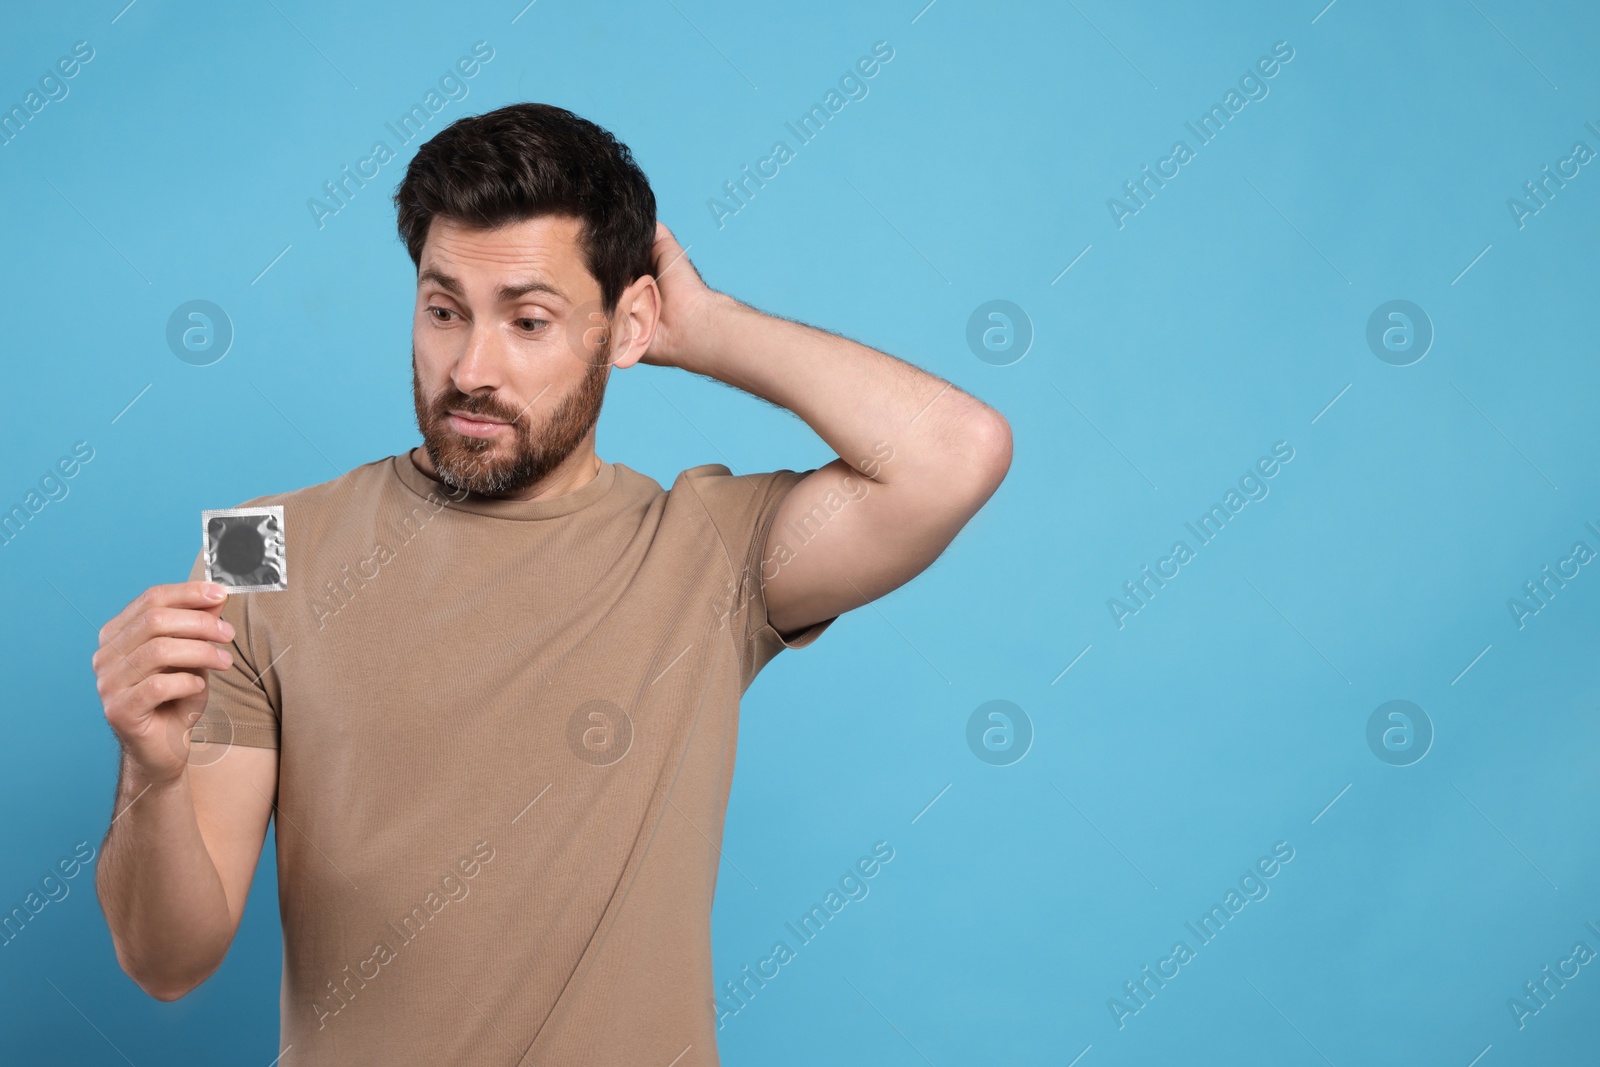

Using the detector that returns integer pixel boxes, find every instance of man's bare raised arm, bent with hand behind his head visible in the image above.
[643,224,1011,635]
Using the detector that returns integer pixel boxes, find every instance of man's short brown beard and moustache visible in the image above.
[411,341,611,496]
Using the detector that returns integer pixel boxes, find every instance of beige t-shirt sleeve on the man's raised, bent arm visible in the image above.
[680,464,838,688]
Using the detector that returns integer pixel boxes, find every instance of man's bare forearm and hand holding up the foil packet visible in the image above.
[93,581,278,1000]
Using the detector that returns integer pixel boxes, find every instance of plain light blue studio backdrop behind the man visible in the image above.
[0,0,1600,1067]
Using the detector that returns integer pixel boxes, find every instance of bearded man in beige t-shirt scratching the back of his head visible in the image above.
[94,104,1011,1067]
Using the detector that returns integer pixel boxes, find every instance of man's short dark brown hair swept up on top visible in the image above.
[395,104,656,315]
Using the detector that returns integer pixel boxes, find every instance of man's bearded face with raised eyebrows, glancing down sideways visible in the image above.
[411,216,611,496]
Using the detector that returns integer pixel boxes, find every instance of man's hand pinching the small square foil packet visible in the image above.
[91,582,234,785]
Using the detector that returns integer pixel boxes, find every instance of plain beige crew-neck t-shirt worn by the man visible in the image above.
[190,450,832,1067]
